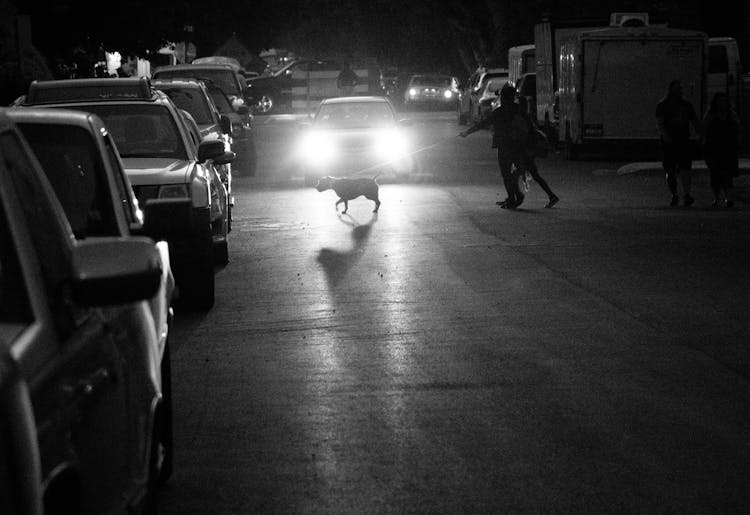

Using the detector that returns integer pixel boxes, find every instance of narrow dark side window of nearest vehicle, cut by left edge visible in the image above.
[0,164,32,324]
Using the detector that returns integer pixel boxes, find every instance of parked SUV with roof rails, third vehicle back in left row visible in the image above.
[24,78,234,310]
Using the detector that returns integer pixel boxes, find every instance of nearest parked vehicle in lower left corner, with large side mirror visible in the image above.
[0,110,164,513]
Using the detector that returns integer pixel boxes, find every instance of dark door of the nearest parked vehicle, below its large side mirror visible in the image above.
[0,133,134,513]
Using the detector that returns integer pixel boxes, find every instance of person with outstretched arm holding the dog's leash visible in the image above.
[459,84,529,209]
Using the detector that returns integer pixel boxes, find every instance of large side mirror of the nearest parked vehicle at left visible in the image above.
[71,238,162,306]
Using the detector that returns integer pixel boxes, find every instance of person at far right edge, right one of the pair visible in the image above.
[703,92,740,207]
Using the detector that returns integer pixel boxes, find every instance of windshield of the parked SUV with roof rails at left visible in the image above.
[81,104,187,159]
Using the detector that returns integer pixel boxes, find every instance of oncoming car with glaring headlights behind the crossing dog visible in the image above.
[296,97,415,186]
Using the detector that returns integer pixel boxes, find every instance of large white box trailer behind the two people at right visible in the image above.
[558,26,708,157]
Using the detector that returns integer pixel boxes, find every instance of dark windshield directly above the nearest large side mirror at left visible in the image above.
[18,123,119,239]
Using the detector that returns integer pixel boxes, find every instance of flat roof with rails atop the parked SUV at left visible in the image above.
[23,77,155,106]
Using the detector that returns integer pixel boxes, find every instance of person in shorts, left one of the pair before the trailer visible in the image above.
[656,80,700,207]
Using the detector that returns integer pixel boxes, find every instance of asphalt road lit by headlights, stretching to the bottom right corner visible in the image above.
[162,114,750,514]
